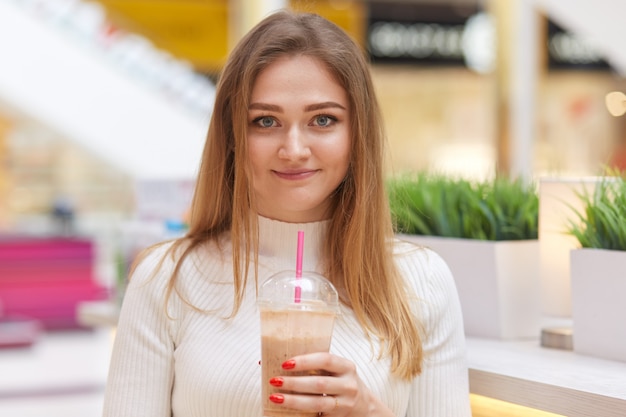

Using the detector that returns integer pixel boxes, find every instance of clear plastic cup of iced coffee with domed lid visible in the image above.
[259,272,338,417]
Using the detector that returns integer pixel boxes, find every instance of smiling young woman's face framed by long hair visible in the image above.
[248,56,350,223]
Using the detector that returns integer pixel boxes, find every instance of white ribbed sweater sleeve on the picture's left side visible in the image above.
[103,244,174,417]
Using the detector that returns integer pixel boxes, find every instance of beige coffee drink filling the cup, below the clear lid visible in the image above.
[261,304,335,417]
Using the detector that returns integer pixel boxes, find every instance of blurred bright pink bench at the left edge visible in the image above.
[0,237,109,330]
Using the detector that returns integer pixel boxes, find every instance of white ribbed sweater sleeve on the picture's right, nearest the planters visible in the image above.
[400,244,471,417]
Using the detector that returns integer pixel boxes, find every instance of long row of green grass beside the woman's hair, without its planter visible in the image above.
[388,172,539,241]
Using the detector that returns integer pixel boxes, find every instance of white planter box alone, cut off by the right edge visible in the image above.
[570,249,626,362]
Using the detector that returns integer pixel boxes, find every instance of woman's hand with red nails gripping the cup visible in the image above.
[270,352,393,417]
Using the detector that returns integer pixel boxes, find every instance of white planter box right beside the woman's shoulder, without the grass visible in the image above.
[398,235,541,339]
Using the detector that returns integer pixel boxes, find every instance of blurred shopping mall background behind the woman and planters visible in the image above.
[0,0,626,417]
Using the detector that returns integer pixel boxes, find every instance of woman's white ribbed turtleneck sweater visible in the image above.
[103,218,471,417]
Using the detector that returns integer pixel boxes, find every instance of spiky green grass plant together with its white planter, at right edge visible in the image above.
[568,172,626,362]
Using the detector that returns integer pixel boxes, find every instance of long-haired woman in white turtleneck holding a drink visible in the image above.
[104,11,470,417]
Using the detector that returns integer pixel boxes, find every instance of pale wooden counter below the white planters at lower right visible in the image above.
[467,338,626,417]
